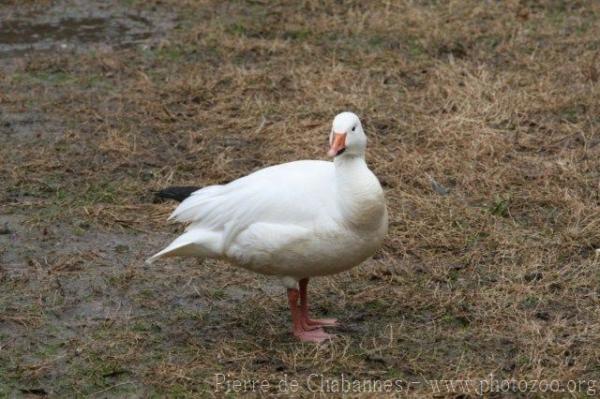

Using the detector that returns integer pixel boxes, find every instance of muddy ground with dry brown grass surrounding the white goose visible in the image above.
[0,0,600,398]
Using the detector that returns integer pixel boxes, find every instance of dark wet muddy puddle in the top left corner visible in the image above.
[0,0,174,58]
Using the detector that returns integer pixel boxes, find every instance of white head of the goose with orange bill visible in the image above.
[327,112,367,157]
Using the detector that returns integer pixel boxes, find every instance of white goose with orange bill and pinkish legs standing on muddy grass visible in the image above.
[148,112,388,342]
